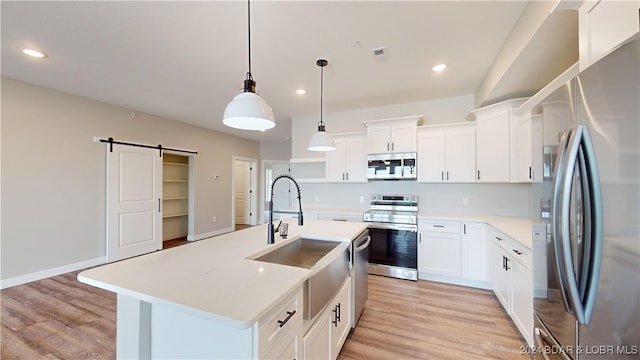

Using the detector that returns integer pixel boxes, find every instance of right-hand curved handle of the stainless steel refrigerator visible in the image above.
[580,125,603,325]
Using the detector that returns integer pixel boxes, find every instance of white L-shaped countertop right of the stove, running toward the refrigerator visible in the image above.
[418,212,542,249]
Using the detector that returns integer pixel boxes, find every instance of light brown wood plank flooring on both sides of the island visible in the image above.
[0,272,524,360]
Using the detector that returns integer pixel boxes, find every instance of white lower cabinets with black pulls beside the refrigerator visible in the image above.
[492,229,533,345]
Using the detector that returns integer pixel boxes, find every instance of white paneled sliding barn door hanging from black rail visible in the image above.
[107,144,162,262]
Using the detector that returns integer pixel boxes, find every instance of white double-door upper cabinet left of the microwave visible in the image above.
[325,133,367,182]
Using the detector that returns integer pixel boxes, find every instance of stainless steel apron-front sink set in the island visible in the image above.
[253,238,349,319]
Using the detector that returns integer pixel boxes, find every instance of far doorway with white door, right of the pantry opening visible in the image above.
[233,157,258,228]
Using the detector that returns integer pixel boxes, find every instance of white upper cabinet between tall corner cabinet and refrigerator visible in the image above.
[512,115,543,183]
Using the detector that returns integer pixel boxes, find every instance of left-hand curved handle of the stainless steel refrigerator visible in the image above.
[551,129,574,314]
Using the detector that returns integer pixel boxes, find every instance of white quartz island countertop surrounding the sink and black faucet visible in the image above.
[78,219,366,328]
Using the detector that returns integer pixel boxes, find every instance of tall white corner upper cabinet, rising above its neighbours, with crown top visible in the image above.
[472,98,526,183]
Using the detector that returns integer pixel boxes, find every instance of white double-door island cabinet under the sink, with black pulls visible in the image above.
[302,277,352,359]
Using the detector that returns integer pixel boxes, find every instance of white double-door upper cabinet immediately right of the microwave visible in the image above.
[418,123,476,182]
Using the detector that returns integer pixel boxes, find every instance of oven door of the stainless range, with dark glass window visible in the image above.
[369,223,418,280]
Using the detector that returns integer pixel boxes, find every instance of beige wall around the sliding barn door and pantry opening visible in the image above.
[0,78,260,279]
